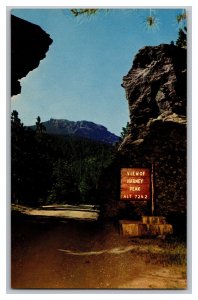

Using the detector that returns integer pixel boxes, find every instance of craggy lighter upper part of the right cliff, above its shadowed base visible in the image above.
[122,44,187,140]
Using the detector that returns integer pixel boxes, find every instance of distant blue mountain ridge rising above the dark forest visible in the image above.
[30,118,119,144]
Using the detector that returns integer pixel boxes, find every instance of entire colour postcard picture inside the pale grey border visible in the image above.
[9,7,189,291]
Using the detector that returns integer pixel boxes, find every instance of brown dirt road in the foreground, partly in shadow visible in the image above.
[11,214,186,289]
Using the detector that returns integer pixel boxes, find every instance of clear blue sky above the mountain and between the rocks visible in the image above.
[11,8,182,135]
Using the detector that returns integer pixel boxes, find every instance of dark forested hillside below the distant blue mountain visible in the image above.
[11,111,114,206]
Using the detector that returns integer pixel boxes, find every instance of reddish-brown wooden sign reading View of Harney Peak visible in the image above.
[120,168,151,201]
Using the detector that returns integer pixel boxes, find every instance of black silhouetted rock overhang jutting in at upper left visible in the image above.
[11,15,52,96]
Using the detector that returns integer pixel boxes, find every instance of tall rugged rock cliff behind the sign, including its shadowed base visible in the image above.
[100,44,187,227]
